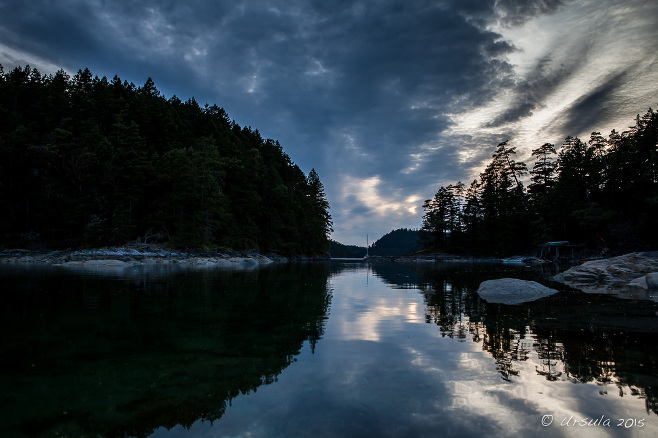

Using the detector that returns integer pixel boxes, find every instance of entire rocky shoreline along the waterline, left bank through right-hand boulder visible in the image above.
[5,243,658,301]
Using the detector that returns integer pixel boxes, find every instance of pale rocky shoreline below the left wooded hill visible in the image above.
[0,244,322,269]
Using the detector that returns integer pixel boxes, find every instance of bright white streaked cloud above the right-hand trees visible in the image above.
[446,1,658,185]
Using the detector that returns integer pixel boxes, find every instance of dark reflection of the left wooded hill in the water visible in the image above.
[0,264,331,437]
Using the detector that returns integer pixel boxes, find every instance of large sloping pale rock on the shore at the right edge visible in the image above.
[553,251,658,296]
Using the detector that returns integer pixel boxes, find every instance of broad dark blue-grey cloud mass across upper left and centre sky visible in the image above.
[2,1,547,152]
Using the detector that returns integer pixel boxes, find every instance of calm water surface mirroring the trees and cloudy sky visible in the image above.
[0,262,658,438]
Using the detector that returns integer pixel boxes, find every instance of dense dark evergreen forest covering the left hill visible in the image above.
[0,66,332,254]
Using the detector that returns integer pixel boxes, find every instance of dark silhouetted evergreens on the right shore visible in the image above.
[421,109,658,254]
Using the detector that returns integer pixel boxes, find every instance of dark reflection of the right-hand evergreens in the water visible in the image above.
[372,263,658,413]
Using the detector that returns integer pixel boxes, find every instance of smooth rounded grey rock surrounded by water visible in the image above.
[478,278,557,305]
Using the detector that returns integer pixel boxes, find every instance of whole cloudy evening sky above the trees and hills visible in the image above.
[0,0,658,245]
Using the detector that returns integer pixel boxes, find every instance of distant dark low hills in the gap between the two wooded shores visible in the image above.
[329,228,420,258]
